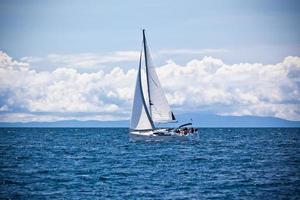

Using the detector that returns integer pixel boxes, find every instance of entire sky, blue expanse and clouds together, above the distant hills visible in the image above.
[0,0,300,122]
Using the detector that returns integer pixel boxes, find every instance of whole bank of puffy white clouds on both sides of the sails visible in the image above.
[0,52,300,121]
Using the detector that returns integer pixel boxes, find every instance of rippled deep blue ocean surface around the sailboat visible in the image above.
[0,128,300,199]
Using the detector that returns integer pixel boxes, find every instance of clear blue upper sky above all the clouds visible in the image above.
[0,0,300,62]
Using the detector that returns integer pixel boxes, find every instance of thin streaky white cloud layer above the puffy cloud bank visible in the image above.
[20,49,229,71]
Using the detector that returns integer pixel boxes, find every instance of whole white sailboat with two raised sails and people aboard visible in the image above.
[130,29,198,137]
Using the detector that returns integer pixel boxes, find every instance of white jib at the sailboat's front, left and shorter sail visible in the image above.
[130,52,154,130]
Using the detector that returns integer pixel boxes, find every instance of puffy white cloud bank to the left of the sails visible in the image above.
[0,50,136,120]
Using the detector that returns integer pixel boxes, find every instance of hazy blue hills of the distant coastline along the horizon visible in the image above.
[0,114,300,128]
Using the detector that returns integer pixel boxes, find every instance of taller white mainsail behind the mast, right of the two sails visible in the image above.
[143,30,176,122]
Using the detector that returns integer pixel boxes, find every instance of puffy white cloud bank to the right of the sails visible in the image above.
[157,57,300,120]
